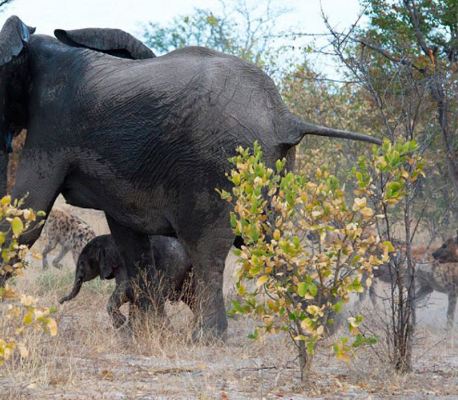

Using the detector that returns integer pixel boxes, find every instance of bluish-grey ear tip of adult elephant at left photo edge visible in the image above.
[0,15,35,66]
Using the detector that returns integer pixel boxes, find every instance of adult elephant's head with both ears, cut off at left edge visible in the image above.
[0,16,155,196]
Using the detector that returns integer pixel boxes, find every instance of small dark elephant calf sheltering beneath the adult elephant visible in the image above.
[59,235,194,328]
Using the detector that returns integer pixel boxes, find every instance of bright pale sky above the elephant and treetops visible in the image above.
[0,0,360,76]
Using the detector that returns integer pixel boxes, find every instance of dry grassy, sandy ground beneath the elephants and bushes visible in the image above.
[0,198,458,400]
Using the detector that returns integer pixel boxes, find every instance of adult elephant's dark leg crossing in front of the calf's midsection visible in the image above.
[107,215,165,328]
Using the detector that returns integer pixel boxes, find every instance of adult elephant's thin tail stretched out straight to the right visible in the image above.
[283,113,382,146]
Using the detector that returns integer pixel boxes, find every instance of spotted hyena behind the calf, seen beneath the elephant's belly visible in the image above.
[43,208,96,269]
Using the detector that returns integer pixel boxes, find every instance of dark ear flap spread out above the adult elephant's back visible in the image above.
[54,28,156,60]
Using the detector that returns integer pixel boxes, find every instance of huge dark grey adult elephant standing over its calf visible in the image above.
[0,16,378,339]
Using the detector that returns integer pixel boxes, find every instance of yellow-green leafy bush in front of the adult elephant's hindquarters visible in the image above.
[220,143,422,378]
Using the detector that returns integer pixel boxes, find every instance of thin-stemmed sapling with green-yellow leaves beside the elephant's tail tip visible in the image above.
[354,140,424,372]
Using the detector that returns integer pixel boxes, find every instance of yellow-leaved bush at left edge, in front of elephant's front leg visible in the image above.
[0,196,57,365]
